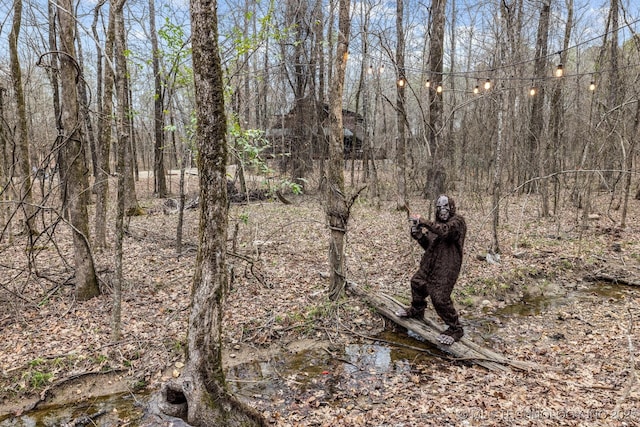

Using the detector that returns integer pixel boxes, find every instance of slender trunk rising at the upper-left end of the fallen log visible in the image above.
[327,0,351,300]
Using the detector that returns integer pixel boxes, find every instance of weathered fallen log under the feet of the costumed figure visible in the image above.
[347,282,541,371]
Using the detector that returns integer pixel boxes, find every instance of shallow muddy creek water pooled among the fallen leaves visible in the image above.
[0,283,640,427]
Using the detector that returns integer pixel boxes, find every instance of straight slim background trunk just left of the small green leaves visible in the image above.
[149,0,167,198]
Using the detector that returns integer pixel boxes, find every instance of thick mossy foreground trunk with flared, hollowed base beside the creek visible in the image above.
[159,0,267,427]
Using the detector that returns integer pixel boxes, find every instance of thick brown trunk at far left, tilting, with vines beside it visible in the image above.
[58,0,100,301]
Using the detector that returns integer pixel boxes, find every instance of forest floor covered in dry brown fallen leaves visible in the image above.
[0,172,640,427]
